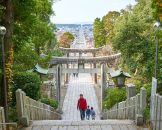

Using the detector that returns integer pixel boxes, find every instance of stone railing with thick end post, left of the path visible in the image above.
[16,89,61,126]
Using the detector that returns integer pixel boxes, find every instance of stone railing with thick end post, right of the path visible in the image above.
[103,88,147,125]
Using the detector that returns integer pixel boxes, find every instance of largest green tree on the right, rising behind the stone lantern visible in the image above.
[113,0,155,81]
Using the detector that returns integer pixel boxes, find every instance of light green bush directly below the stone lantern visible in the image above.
[103,88,126,109]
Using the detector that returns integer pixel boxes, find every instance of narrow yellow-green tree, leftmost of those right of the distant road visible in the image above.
[93,18,106,47]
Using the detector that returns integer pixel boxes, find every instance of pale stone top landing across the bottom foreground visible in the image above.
[18,120,149,130]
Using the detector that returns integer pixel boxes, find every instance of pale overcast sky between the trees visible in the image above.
[51,0,135,23]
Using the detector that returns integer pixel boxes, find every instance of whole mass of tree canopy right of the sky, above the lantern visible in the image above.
[94,0,162,83]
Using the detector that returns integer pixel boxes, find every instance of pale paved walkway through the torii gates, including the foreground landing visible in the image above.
[18,25,148,130]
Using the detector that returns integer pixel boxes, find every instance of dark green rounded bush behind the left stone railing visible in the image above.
[13,72,41,103]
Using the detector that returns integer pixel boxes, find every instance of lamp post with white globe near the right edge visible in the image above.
[154,22,160,78]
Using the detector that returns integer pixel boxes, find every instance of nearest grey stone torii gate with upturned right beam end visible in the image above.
[49,53,121,110]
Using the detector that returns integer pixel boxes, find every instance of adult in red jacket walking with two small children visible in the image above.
[77,94,96,120]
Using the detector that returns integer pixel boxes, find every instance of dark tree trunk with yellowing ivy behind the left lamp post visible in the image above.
[0,0,13,104]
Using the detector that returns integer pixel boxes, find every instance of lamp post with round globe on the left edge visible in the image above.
[0,26,8,121]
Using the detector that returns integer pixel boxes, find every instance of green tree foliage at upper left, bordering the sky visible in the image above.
[14,0,56,55]
